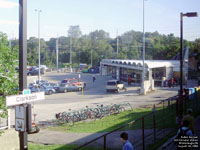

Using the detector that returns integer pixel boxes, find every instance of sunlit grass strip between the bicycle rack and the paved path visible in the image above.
[48,105,175,133]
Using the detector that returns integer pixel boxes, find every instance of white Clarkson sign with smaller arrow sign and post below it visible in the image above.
[6,89,45,150]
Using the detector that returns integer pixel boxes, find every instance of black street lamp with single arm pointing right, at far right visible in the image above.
[180,12,197,98]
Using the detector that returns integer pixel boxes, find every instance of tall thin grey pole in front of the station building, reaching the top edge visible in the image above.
[141,0,145,94]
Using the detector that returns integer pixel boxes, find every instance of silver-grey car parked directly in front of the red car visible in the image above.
[58,83,84,93]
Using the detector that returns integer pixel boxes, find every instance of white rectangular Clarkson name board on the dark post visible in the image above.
[6,92,44,107]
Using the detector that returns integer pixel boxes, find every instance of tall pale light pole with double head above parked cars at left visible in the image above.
[35,9,42,83]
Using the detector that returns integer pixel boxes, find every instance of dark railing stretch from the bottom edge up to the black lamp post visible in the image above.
[74,96,180,150]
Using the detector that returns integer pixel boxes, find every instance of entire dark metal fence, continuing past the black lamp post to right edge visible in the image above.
[74,91,200,150]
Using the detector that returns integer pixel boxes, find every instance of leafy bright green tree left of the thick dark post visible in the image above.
[0,33,19,117]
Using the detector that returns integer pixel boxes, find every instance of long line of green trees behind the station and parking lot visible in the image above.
[9,25,200,67]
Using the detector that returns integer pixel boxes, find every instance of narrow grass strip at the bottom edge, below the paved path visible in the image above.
[28,143,119,150]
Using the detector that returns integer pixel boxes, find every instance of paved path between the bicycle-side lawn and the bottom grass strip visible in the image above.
[28,129,156,149]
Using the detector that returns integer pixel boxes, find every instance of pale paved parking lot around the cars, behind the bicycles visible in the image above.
[11,72,178,124]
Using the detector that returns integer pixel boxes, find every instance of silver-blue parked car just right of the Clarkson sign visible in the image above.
[30,85,56,95]
